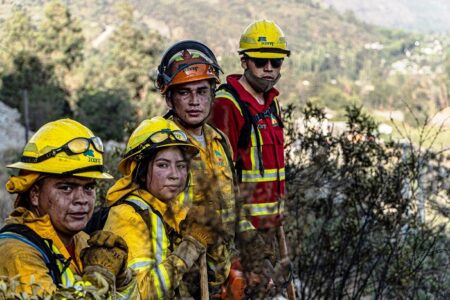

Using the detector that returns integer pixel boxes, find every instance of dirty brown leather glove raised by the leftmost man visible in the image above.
[81,230,132,288]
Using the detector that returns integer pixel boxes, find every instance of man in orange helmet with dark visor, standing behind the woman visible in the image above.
[157,40,241,295]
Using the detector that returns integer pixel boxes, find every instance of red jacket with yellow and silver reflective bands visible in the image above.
[211,75,285,230]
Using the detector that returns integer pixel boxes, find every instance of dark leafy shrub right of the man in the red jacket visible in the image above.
[285,104,450,299]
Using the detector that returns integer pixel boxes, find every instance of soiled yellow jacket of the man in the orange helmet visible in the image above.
[174,119,236,287]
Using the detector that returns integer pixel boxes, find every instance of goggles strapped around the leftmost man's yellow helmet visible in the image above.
[20,136,104,163]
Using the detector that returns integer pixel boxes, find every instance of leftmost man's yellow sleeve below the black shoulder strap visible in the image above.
[0,239,56,295]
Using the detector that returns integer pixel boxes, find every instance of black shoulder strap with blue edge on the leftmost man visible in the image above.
[0,224,62,286]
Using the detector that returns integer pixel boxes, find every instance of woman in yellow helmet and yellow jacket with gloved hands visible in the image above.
[104,117,220,299]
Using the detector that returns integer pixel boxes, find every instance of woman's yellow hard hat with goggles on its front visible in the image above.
[119,117,199,174]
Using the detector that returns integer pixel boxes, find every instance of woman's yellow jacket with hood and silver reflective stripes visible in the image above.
[104,190,193,299]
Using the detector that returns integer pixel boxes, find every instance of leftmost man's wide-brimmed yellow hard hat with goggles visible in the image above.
[7,119,113,179]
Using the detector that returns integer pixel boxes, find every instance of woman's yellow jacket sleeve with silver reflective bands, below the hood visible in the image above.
[104,204,194,299]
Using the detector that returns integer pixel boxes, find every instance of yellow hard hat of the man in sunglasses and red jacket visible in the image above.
[239,20,291,58]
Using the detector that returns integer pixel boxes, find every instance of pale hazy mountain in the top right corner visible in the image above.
[321,0,450,33]
